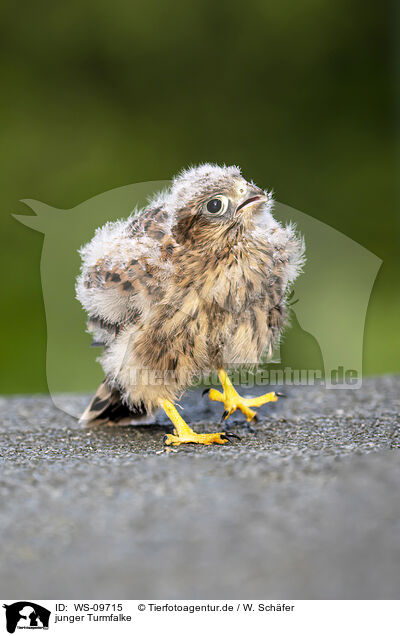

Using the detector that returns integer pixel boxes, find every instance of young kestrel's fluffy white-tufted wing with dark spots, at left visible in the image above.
[76,208,174,345]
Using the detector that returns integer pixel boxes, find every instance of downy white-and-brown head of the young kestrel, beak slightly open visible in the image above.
[155,164,273,247]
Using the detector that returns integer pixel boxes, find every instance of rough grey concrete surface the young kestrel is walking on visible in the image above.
[0,377,400,599]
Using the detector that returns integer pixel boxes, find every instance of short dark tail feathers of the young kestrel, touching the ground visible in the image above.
[79,380,154,426]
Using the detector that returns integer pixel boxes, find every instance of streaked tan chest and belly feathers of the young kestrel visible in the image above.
[138,241,281,369]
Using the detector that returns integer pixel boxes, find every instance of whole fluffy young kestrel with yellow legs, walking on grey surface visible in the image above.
[76,163,305,446]
